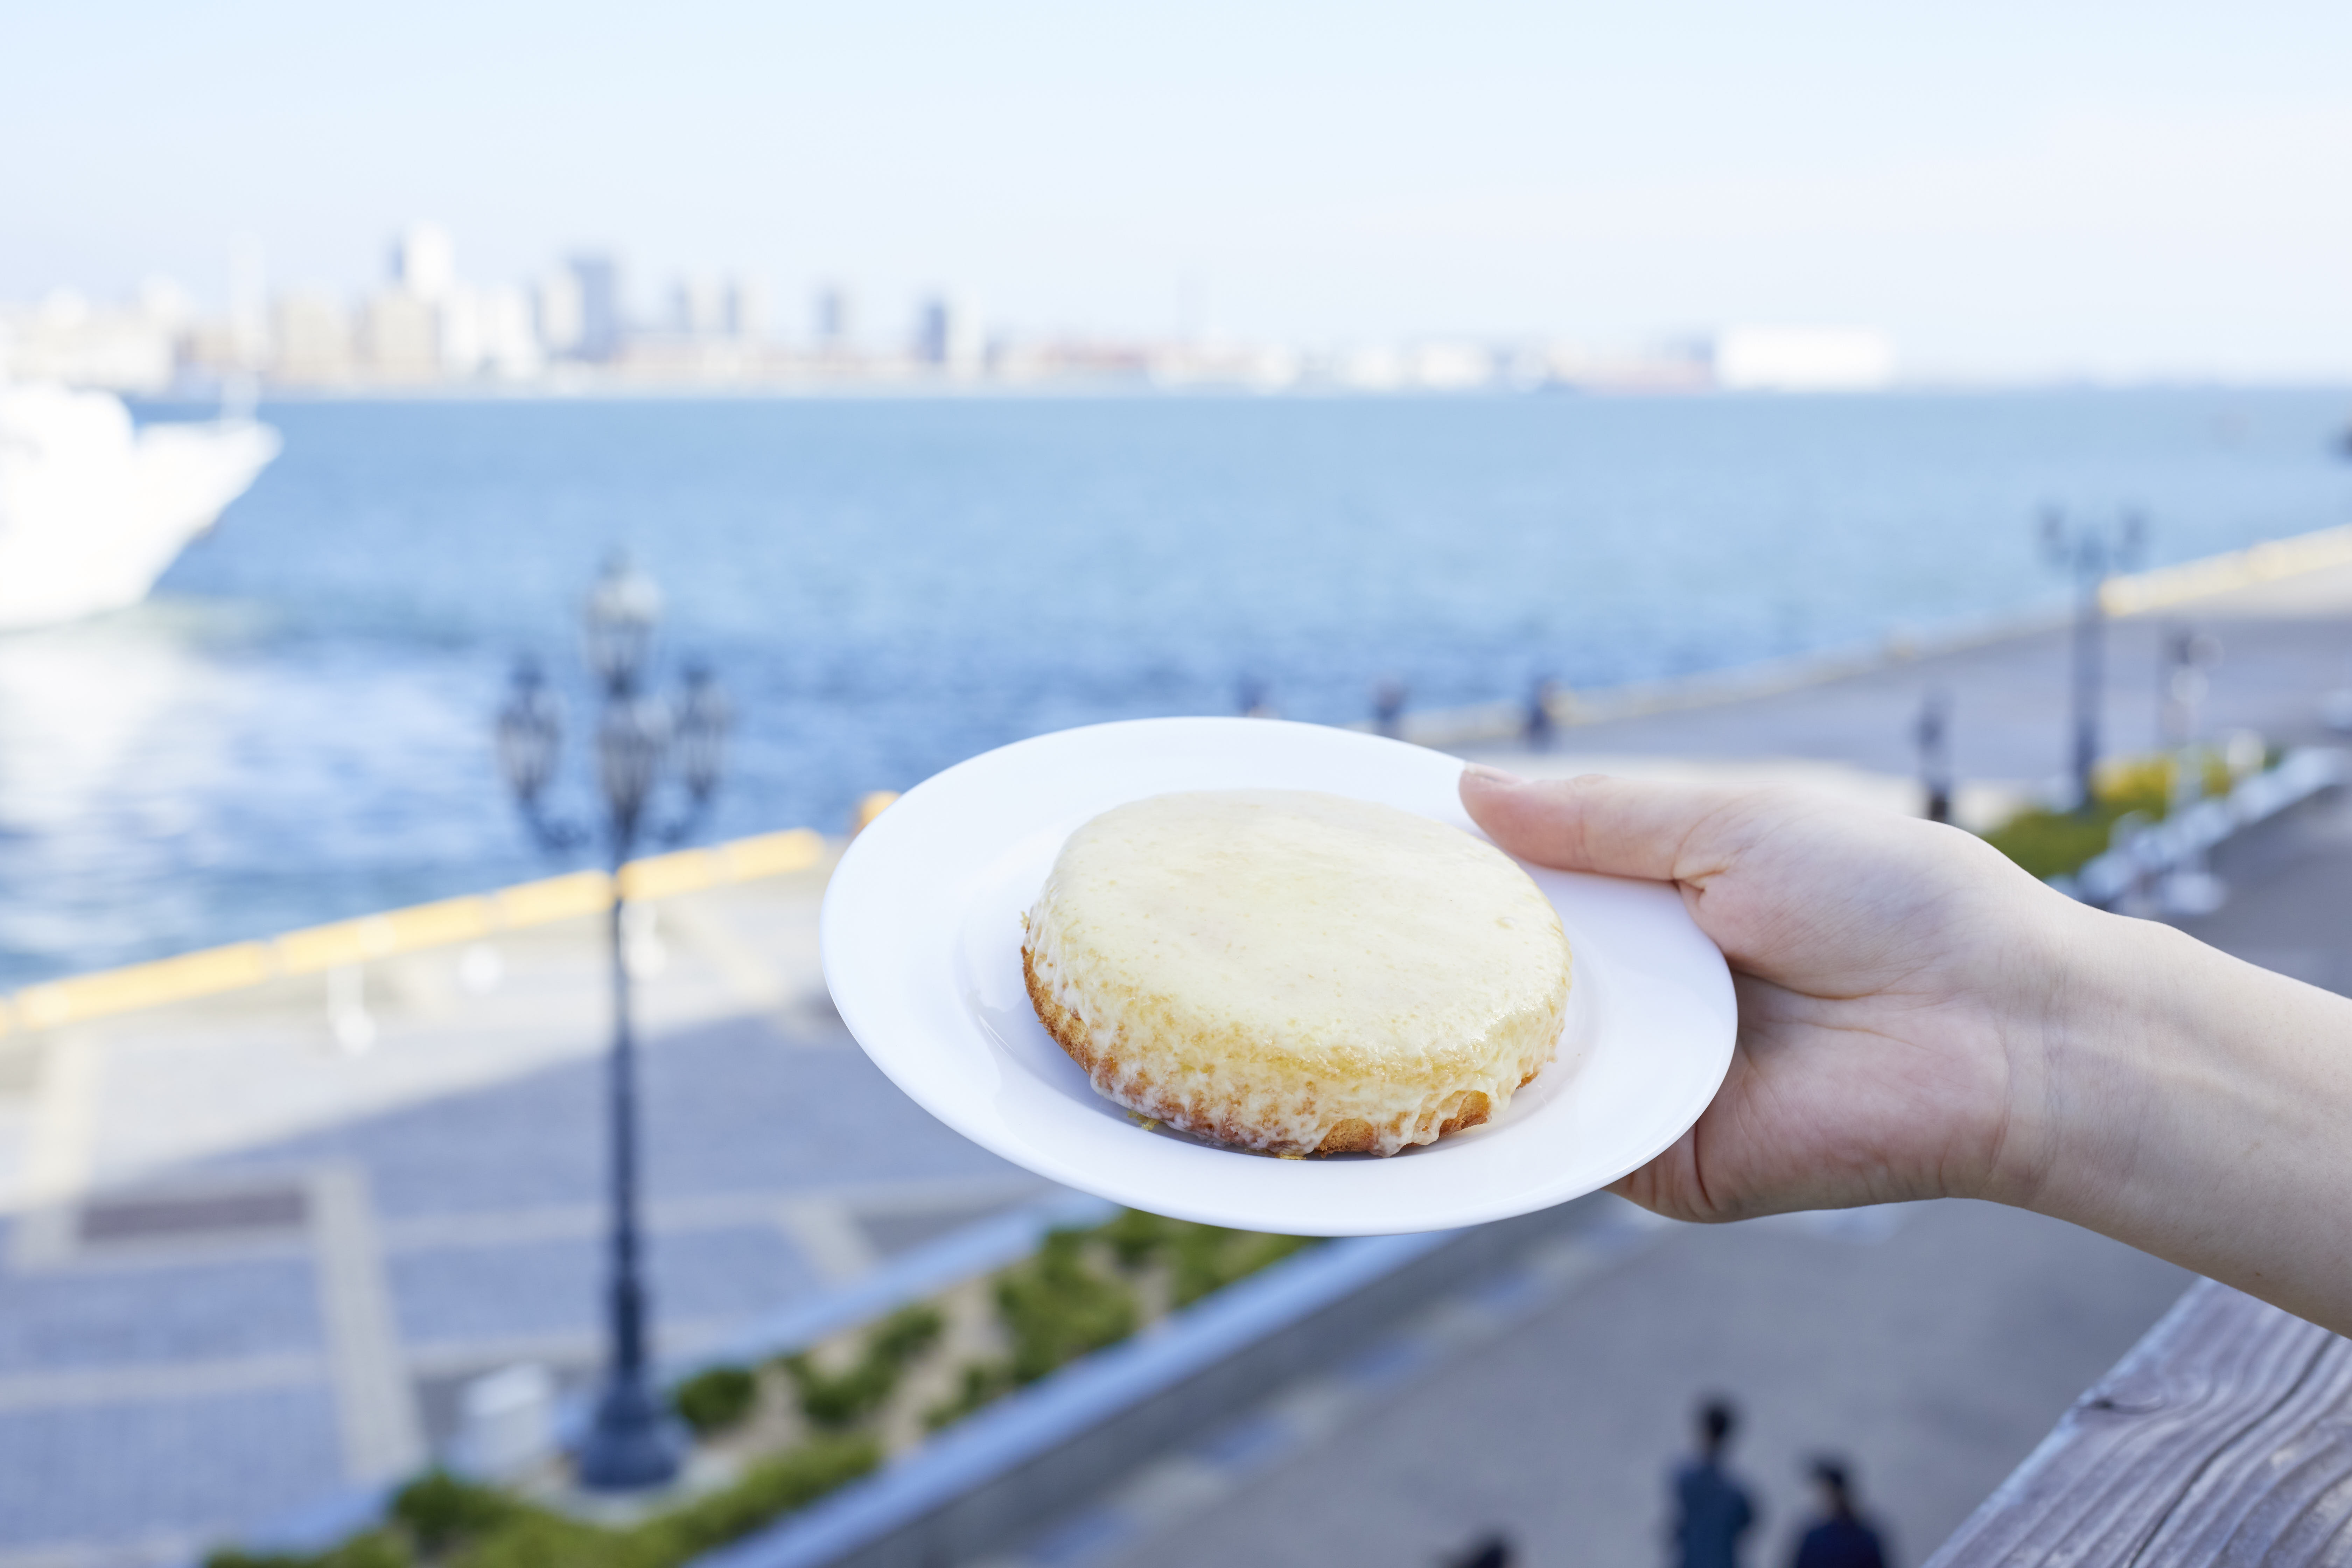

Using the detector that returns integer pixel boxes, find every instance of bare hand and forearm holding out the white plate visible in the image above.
[1461,769,2352,1333]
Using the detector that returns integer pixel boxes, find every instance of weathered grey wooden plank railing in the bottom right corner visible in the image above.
[1928,1281,2352,1568]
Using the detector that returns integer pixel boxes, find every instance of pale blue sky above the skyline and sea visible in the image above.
[0,0,2352,378]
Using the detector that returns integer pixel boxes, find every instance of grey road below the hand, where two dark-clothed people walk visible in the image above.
[990,1204,2188,1568]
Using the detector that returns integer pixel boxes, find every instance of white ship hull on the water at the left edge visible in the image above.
[0,386,280,630]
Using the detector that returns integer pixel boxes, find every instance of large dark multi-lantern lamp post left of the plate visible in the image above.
[499,555,732,1490]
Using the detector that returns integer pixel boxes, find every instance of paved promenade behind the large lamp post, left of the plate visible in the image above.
[0,867,1046,1566]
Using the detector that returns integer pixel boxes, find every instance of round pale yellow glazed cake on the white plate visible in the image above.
[1028,790,1569,1149]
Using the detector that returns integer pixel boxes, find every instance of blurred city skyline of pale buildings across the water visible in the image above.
[0,223,1893,395]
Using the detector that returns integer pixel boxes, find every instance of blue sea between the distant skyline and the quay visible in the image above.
[0,390,2352,985]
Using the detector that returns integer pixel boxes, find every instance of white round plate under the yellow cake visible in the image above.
[823,719,1738,1237]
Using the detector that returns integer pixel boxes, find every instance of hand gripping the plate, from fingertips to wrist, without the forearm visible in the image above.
[1461,766,2074,1220]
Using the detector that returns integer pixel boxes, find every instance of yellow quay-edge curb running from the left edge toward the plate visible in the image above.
[0,827,826,1034]
